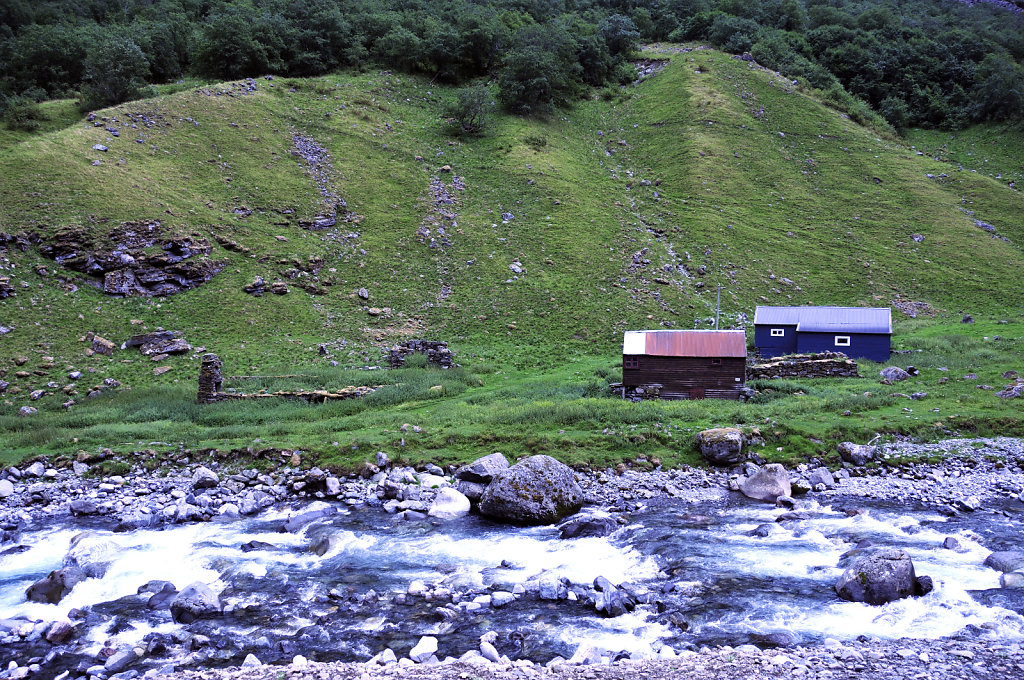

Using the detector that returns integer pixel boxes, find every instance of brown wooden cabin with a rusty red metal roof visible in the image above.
[623,331,746,399]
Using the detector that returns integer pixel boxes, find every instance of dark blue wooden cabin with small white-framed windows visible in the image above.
[754,307,893,364]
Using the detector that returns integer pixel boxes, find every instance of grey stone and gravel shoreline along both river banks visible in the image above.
[0,438,1024,680]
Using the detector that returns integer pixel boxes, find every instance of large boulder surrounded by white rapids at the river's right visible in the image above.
[836,548,930,604]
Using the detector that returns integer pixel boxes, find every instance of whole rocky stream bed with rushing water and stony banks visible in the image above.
[0,438,1024,680]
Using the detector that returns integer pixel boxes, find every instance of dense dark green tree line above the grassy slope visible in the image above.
[0,0,1024,129]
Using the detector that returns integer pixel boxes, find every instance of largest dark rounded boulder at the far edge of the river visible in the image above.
[480,456,584,524]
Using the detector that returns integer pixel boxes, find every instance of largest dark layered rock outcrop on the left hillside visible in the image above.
[39,220,224,297]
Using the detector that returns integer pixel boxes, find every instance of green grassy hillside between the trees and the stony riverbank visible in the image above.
[0,47,1024,462]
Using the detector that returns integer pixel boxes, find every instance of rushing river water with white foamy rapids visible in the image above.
[0,497,1024,673]
